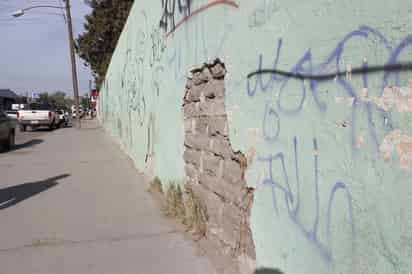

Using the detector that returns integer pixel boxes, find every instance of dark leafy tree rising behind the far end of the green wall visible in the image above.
[76,0,134,88]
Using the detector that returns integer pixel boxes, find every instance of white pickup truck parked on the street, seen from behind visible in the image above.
[17,104,59,131]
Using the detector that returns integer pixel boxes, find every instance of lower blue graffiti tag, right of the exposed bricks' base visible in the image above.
[258,137,355,264]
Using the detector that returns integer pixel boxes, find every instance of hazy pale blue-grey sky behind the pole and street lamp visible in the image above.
[0,0,93,95]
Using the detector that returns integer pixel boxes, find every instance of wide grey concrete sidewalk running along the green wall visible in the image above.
[0,121,214,274]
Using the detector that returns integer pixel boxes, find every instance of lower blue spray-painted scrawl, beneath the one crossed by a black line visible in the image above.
[258,137,355,264]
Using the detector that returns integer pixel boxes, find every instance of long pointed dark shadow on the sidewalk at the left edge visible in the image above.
[0,174,70,210]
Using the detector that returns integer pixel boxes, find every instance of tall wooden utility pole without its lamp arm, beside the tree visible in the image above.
[63,0,81,128]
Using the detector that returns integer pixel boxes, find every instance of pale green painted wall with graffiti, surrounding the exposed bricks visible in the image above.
[99,0,412,273]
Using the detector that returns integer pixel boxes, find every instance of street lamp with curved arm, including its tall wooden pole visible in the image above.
[12,0,81,128]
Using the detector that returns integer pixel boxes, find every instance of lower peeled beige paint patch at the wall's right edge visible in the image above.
[380,129,412,169]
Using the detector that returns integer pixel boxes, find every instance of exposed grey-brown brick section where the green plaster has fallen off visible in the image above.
[183,60,256,273]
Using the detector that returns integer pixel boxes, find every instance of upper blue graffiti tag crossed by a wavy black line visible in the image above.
[246,26,412,150]
